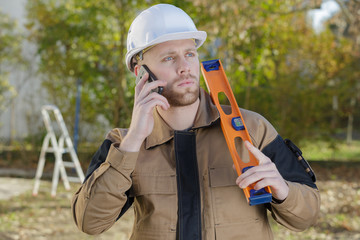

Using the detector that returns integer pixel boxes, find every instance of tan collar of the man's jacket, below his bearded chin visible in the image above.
[145,88,220,149]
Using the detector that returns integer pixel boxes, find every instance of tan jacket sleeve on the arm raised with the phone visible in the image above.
[72,130,138,234]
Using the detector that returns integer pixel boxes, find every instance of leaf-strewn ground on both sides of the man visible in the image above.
[0,162,360,240]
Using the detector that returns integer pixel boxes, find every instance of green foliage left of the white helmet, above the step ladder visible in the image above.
[27,0,152,135]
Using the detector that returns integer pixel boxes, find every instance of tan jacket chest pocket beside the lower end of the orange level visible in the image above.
[209,167,266,226]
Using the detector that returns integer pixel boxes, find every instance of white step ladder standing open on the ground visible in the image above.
[33,105,85,197]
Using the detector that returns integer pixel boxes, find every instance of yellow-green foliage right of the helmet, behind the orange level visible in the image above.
[195,0,359,141]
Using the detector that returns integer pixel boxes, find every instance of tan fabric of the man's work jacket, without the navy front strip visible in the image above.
[72,90,320,240]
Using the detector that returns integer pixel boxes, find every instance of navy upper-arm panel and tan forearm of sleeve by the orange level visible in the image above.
[262,135,320,231]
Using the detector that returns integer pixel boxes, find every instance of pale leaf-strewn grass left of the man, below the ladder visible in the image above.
[0,180,133,240]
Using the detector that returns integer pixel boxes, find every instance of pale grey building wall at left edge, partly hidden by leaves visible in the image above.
[0,0,47,143]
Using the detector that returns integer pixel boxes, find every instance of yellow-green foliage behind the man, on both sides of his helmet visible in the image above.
[27,0,360,142]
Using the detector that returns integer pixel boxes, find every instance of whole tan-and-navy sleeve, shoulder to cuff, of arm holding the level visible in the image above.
[244,111,320,231]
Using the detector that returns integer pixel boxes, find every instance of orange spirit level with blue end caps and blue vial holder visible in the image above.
[201,59,272,206]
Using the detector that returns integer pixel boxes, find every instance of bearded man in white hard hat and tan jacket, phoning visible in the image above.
[72,4,320,240]
